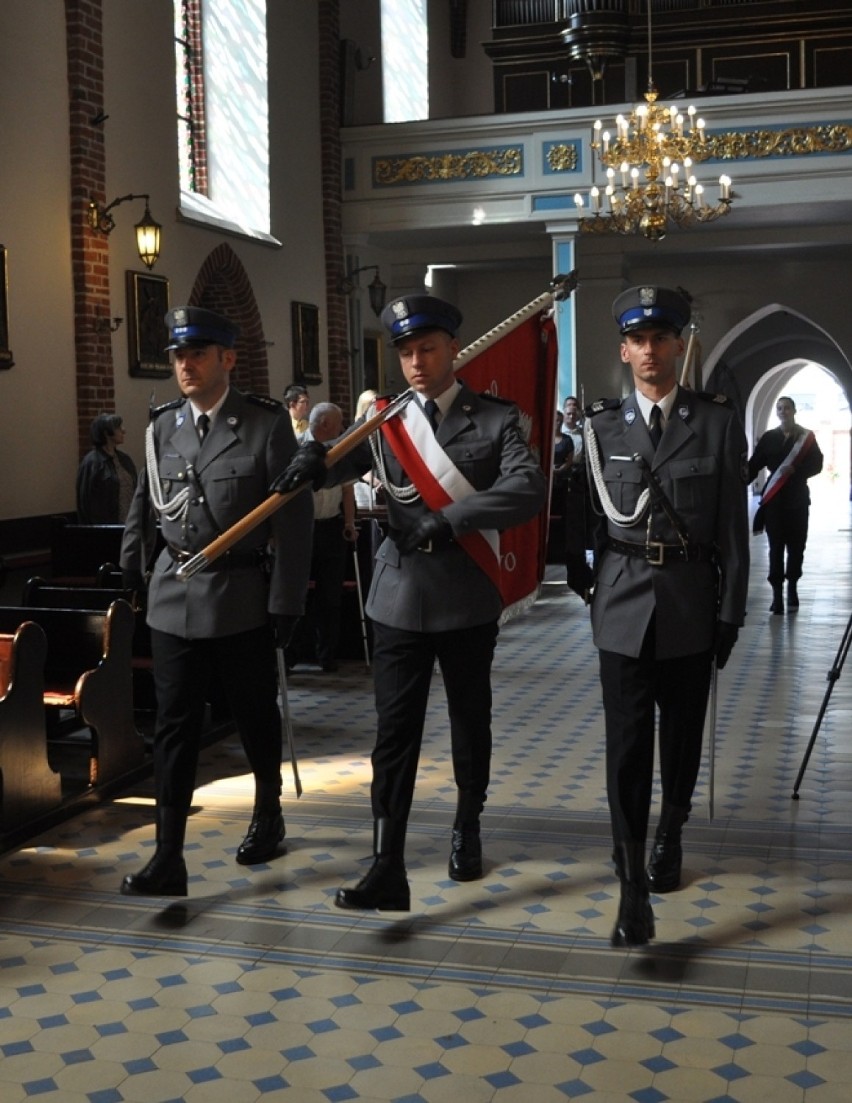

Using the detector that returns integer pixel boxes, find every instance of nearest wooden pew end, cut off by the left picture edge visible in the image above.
[0,621,62,831]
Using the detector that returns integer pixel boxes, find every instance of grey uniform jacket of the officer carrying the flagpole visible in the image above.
[332,384,546,632]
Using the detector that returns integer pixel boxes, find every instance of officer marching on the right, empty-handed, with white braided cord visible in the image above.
[586,287,748,946]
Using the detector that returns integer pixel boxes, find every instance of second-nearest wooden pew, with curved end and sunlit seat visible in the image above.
[0,600,145,785]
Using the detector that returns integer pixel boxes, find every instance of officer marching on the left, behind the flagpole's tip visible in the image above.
[121,307,313,896]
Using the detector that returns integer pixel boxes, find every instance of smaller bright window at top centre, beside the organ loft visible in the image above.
[382,0,429,122]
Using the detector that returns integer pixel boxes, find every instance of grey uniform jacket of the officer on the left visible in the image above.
[121,387,313,639]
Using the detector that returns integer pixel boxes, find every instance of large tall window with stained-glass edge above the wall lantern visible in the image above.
[174,0,270,238]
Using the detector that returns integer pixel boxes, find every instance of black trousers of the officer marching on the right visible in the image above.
[599,621,713,843]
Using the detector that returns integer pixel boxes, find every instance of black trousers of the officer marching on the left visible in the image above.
[146,624,281,808]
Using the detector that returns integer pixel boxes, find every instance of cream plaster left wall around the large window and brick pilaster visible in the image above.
[0,0,328,520]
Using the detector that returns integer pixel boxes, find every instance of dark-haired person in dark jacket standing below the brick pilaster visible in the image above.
[76,414,137,525]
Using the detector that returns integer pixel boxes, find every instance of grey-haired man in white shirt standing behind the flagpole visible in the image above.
[295,403,358,673]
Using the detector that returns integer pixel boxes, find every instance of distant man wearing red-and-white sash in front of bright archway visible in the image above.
[748,395,822,613]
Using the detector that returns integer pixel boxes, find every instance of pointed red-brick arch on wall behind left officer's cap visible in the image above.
[190,242,269,395]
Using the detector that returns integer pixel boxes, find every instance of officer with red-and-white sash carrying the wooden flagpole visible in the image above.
[276,296,546,911]
